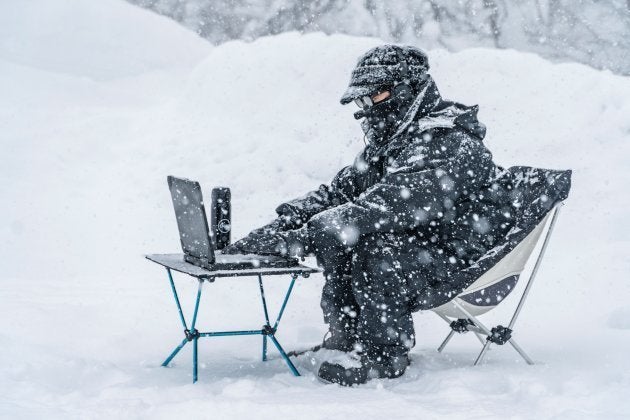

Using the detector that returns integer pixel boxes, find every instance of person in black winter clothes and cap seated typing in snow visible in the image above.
[224,45,511,385]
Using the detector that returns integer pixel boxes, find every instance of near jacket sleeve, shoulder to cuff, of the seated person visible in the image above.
[308,130,495,247]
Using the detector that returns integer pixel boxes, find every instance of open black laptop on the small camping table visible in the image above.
[167,176,298,271]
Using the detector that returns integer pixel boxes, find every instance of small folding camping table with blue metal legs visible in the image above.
[146,254,320,383]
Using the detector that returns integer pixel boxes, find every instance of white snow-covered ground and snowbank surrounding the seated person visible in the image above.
[0,0,630,419]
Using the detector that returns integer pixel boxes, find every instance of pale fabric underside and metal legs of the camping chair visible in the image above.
[431,202,563,366]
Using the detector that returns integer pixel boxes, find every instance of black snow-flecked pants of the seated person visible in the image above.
[317,233,461,354]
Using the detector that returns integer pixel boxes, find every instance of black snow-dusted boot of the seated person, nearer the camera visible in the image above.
[317,353,410,386]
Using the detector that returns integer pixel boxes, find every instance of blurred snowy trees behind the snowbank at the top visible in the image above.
[129,0,630,74]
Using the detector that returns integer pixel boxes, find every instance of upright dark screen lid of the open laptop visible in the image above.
[168,176,214,263]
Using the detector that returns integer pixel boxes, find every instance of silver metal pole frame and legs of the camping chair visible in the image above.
[436,202,563,366]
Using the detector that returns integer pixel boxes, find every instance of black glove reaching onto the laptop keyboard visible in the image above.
[222,222,311,257]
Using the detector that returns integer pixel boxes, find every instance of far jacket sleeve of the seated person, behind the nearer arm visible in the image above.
[276,166,357,228]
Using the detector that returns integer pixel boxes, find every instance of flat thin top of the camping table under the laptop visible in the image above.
[145,254,321,281]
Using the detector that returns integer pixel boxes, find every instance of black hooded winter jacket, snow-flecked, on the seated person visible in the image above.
[276,83,502,257]
